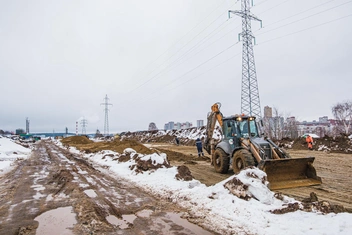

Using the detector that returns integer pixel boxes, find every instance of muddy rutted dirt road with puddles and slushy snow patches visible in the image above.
[0,141,216,235]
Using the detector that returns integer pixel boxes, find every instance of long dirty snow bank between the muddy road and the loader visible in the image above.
[51,142,352,235]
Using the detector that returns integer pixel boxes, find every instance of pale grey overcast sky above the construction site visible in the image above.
[0,0,352,133]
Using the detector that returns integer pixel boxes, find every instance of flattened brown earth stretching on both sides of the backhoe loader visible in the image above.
[145,143,352,212]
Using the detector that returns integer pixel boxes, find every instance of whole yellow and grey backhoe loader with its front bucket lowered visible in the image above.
[204,103,322,190]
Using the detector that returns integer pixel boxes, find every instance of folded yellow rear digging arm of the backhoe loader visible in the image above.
[204,103,223,155]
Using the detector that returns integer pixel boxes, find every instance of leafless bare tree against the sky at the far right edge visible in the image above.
[331,101,352,134]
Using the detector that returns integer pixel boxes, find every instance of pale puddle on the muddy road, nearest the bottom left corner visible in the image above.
[34,206,77,235]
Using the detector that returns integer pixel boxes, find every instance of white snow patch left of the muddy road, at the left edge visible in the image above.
[0,136,31,175]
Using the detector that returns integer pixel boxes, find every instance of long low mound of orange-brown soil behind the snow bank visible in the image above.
[61,136,155,154]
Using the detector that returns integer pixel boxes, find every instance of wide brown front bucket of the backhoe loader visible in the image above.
[258,157,322,190]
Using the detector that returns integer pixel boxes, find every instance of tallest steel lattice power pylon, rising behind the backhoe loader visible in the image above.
[228,0,262,119]
